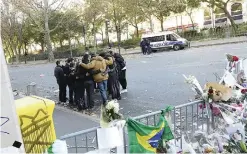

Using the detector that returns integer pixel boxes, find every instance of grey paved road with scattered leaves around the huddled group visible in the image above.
[9,43,247,134]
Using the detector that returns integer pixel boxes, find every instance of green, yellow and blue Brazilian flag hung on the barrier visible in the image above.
[127,115,174,153]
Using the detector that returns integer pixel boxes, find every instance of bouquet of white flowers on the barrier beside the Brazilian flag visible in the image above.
[101,100,123,126]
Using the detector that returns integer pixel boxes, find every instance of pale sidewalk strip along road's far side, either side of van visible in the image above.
[121,36,247,55]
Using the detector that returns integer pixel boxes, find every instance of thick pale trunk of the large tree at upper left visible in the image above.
[44,0,55,62]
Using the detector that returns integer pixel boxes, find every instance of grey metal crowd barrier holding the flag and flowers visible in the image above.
[60,100,213,153]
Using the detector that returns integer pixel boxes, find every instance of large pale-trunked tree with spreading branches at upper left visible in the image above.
[12,0,63,62]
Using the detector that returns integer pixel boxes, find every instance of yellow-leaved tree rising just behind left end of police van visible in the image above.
[124,0,145,37]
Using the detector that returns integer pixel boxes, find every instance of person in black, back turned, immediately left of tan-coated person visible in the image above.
[82,53,94,109]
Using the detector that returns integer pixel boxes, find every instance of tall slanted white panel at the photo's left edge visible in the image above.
[0,37,25,152]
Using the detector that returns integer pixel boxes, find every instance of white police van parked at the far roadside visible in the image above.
[142,31,190,52]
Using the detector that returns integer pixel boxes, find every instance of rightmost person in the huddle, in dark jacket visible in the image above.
[109,51,127,93]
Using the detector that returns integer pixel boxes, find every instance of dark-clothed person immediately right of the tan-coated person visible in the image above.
[105,53,121,100]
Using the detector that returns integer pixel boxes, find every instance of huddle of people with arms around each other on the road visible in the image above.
[54,51,127,110]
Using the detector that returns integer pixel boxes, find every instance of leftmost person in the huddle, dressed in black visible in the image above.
[54,61,66,103]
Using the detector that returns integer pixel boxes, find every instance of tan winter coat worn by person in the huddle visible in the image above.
[81,56,113,83]
